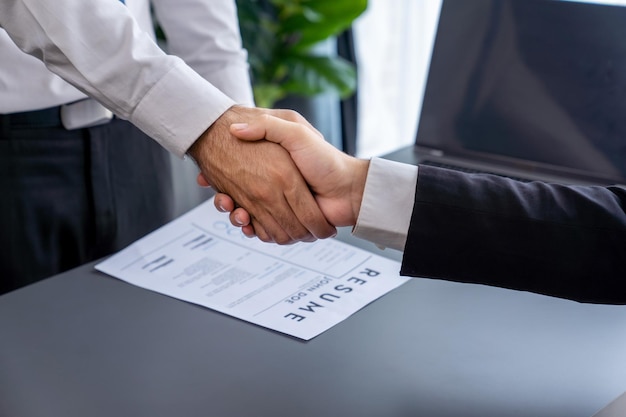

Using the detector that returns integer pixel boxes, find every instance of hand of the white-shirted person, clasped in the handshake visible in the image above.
[189,107,336,244]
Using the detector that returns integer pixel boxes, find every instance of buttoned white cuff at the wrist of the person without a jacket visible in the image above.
[130,60,235,158]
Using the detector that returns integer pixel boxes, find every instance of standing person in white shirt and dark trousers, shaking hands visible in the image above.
[0,0,335,293]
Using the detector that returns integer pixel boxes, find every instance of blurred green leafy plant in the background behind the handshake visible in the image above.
[237,0,367,107]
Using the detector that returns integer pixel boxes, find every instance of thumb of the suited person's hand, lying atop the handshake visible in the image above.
[230,114,312,152]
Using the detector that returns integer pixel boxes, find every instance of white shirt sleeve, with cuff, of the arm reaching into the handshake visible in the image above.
[0,0,235,156]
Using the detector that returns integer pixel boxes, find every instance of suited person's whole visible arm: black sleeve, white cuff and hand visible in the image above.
[208,116,626,304]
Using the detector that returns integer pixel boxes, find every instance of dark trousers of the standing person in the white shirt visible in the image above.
[0,118,173,294]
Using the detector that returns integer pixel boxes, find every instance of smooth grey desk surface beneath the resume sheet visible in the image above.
[0,145,626,417]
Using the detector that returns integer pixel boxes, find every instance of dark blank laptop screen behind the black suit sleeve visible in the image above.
[416,0,626,183]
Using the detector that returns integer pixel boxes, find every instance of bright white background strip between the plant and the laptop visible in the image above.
[354,0,441,158]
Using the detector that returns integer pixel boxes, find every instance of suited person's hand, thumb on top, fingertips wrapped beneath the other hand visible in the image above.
[205,114,369,236]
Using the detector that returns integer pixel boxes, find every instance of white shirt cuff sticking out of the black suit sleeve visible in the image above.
[352,158,418,251]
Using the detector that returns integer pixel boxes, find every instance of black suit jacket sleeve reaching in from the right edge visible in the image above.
[401,166,626,304]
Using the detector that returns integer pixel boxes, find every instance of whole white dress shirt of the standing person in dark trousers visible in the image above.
[0,0,253,156]
